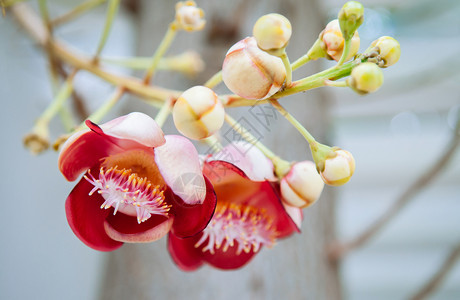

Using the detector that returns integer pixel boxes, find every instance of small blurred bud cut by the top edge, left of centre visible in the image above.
[176,1,206,31]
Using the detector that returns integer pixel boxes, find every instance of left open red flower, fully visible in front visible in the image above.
[59,113,216,251]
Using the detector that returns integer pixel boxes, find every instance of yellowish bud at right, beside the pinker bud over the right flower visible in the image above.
[320,148,355,186]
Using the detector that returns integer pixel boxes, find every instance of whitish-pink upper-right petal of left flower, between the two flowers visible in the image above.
[154,135,206,205]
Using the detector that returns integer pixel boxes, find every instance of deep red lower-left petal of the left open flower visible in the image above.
[65,179,123,251]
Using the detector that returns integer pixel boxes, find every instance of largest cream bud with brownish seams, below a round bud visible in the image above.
[222,37,286,99]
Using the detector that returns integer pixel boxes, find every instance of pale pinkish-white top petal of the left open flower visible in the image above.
[100,112,165,147]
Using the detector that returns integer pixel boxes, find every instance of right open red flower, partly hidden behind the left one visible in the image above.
[168,143,302,271]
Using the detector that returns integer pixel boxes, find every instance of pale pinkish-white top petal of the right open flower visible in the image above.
[208,141,277,181]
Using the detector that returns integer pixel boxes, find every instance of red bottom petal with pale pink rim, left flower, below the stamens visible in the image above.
[104,212,174,243]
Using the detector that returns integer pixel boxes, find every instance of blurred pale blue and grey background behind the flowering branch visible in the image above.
[0,0,460,299]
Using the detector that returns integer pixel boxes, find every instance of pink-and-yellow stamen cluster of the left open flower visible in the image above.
[84,166,171,224]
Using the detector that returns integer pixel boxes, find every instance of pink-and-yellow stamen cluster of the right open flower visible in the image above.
[195,204,278,255]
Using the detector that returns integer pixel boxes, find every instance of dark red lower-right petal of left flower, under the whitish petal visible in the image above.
[167,176,217,238]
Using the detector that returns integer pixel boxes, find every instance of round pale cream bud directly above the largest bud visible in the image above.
[252,13,292,50]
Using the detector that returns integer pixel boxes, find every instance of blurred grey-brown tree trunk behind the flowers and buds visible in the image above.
[101,0,341,299]
